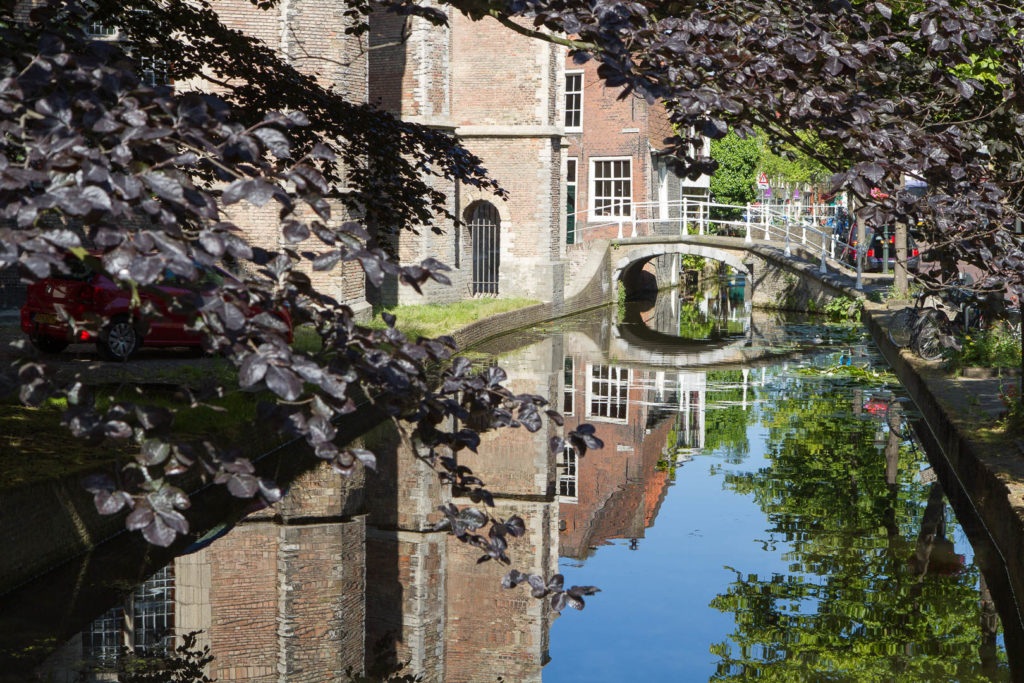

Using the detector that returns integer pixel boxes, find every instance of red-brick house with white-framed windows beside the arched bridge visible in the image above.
[563,59,710,244]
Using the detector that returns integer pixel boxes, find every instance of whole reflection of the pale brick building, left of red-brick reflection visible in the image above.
[44,340,563,682]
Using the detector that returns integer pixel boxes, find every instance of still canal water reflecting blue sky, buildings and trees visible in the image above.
[6,283,1021,683]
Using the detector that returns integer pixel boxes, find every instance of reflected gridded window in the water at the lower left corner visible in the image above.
[82,565,174,667]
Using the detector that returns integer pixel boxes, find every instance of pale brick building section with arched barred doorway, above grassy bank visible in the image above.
[370,8,565,303]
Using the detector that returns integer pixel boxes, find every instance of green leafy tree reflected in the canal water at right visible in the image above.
[712,381,1009,681]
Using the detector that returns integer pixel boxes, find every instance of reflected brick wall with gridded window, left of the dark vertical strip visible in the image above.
[43,464,366,682]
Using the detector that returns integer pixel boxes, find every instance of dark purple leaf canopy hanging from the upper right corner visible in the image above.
[509,0,1024,296]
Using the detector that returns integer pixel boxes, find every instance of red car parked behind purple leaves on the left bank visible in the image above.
[22,259,292,360]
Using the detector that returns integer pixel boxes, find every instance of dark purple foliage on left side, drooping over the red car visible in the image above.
[0,1,601,581]
